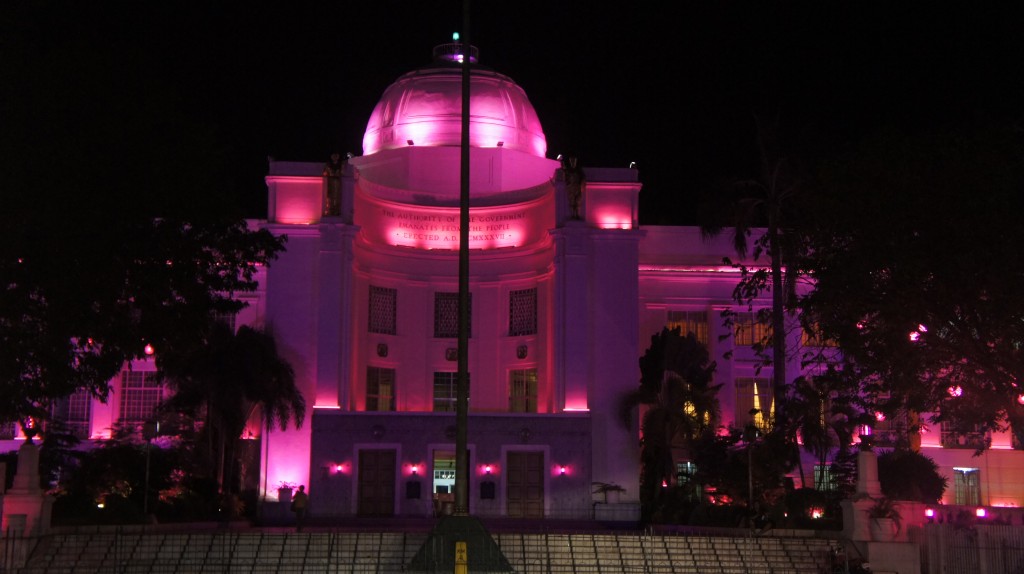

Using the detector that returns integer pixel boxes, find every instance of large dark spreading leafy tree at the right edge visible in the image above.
[801,118,1024,448]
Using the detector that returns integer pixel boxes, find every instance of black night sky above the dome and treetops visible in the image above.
[0,0,1024,223]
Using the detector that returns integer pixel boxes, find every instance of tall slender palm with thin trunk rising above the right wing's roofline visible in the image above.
[700,114,800,429]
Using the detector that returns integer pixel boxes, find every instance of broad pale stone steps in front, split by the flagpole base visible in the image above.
[4,529,839,574]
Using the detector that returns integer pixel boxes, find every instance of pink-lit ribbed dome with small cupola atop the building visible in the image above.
[362,44,548,158]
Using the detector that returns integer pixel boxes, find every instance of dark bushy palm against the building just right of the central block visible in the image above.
[620,326,722,514]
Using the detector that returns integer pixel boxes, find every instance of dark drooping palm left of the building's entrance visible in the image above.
[160,322,306,503]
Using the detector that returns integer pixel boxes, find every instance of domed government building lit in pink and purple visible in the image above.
[8,45,1024,520]
